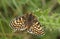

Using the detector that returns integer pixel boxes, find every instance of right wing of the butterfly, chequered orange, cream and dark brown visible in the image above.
[27,22,44,35]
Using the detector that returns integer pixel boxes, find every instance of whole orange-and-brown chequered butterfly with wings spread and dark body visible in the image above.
[10,13,44,35]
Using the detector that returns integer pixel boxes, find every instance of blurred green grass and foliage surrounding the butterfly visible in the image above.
[0,0,60,39]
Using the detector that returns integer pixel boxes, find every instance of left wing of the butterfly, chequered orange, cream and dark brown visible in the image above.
[10,16,27,31]
